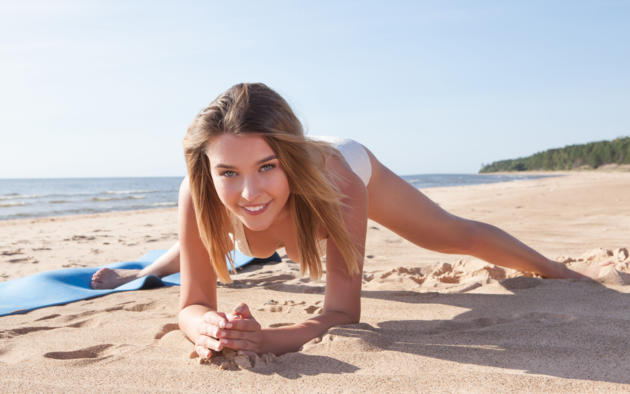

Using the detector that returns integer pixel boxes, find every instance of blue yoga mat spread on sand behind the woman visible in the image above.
[0,250,280,316]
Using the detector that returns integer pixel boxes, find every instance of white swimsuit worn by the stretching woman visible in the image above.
[230,136,372,257]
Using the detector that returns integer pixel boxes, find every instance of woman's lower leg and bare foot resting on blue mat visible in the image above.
[91,242,179,289]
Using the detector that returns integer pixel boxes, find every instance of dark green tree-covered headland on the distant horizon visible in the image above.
[479,137,630,173]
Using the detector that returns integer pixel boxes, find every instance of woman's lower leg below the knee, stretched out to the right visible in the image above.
[468,222,573,278]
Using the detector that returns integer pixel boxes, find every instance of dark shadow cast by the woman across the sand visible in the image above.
[236,275,630,384]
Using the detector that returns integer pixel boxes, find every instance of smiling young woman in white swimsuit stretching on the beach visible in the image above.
[94,84,584,357]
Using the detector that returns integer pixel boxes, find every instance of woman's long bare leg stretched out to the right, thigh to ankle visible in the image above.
[368,151,585,278]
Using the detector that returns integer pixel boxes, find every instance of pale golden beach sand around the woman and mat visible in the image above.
[0,172,630,392]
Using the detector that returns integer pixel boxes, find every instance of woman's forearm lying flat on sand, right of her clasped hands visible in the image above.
[261,312,356,355]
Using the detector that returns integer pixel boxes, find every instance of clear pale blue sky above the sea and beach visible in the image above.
[0,0,630,178]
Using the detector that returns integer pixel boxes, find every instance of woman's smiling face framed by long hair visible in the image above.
[206,134,290,231]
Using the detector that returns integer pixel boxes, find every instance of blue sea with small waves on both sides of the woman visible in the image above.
[0,174,545,220]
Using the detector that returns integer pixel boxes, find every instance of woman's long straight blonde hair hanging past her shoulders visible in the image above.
[183,83,360,283]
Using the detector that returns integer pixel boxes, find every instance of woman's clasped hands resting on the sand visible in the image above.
[195,303,262,359]
